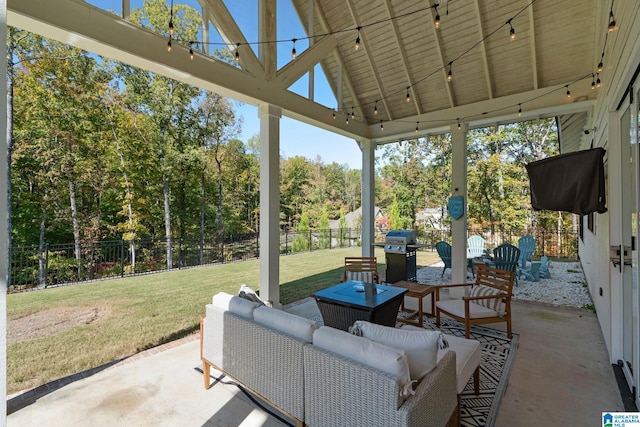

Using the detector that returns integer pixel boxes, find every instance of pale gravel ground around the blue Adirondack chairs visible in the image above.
[417,261,593,308]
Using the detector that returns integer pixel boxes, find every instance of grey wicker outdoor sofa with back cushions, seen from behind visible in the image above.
[200,293,458,427]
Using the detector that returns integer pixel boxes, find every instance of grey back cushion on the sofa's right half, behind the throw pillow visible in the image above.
[313,326,412,397]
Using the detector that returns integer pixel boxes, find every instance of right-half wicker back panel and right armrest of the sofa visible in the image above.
[304,345,457,427]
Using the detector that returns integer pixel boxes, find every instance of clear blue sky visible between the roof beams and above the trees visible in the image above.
[93,0,362,169]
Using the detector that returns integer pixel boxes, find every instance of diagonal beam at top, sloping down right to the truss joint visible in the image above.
[204,0,264,75]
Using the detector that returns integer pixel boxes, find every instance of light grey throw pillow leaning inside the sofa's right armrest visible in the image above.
[349,320,447,380]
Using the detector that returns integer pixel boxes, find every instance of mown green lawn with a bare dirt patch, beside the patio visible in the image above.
[7,248,439,394]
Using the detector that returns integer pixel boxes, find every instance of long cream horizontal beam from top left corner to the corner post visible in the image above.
[7,0,368,139]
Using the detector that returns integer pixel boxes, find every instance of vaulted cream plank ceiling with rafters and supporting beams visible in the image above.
[8,0,613,151]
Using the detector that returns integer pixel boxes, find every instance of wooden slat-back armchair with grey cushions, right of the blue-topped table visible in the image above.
[436,262,517,338]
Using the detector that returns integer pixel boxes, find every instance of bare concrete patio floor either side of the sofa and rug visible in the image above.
[7,302,624,427]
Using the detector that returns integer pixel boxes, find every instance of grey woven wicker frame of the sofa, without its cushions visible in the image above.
[200,305,457,427]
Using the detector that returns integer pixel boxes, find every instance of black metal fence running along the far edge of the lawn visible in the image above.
[9,228,578,292]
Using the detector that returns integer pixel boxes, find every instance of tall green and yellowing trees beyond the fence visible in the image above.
[7,0,567,274]
